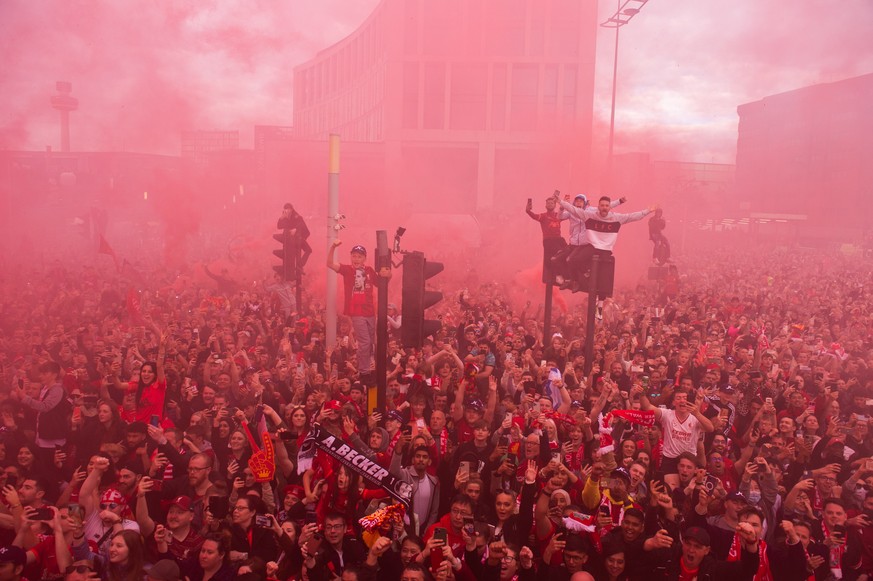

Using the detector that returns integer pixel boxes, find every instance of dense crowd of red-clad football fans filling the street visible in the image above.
[0,218,873,581]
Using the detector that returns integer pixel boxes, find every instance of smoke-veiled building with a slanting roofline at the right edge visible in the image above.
[736,74,873,241]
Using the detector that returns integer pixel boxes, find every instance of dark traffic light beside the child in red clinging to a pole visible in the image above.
[400,252,443,347]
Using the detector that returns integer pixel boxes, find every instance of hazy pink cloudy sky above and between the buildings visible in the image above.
[0,0,873,163]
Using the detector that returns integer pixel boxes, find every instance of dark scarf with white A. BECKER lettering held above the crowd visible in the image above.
[298,424,412,510]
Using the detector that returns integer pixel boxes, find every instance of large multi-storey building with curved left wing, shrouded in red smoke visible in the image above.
[294,0,597,213]
